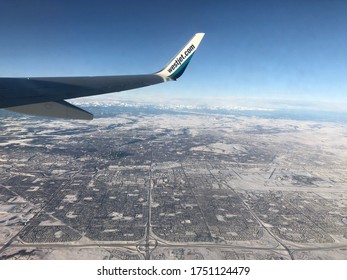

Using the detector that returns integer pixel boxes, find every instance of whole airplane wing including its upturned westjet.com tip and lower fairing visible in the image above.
[0,33,205,120]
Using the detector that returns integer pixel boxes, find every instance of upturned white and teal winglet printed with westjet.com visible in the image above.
[156,33,205,81]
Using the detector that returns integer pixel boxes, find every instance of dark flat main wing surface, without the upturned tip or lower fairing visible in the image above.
[0,74,164,108]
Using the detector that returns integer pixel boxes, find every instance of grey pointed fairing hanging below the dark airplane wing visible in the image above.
[6,101,93,120]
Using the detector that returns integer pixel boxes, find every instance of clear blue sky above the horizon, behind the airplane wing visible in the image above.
[0,0,347,107]
